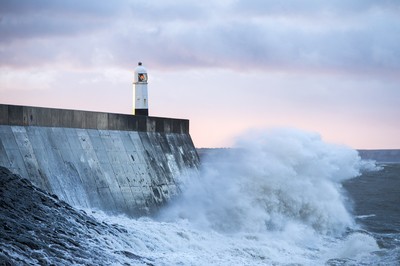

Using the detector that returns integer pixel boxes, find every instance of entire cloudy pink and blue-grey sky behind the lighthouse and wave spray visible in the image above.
[0,0,400,149]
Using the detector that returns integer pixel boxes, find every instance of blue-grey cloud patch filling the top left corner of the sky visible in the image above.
[0,0,122,43]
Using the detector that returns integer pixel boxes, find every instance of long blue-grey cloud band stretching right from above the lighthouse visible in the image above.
[119,17,400,71]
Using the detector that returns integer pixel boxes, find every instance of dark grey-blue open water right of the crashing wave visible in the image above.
[344,163,400,265]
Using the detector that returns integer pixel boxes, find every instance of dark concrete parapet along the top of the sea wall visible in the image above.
[0,104,189,134]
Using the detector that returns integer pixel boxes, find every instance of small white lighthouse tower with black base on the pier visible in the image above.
[133,62,149,116]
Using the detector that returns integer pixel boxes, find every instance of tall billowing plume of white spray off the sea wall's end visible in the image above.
[162,128,362,234]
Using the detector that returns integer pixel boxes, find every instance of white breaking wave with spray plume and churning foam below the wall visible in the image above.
[0,129,394,265]
